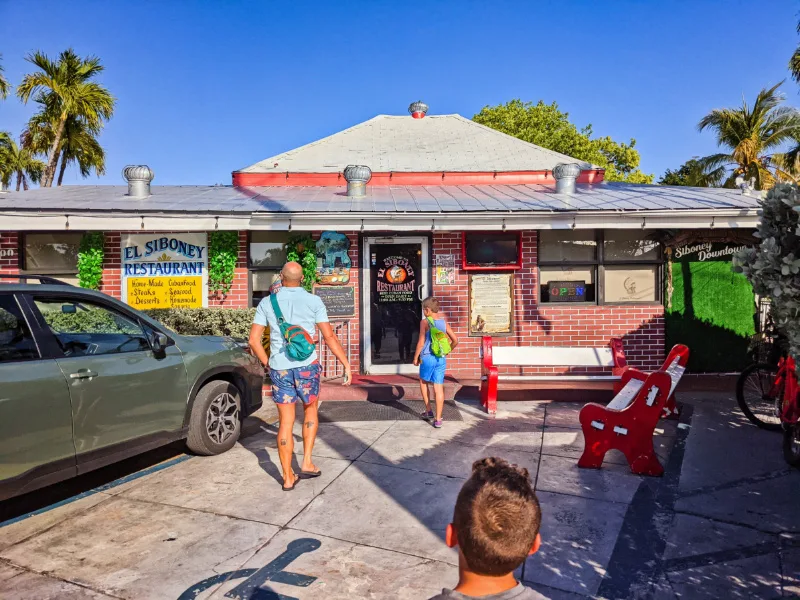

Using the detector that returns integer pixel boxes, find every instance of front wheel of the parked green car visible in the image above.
[186,380,242,456]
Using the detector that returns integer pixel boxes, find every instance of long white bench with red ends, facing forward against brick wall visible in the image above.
[481,337,627,414]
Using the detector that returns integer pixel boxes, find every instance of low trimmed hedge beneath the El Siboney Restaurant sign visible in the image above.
[143,308,256,339]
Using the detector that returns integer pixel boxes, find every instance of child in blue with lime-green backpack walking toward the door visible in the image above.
[414,296,458,429]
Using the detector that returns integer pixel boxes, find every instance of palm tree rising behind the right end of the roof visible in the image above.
[697,82,800,190]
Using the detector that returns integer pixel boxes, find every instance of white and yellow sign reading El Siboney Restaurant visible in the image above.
[121,233,208,309]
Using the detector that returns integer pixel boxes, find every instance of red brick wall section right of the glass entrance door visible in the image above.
[433,231,664,377]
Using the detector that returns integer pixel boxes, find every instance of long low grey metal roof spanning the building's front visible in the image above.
[0,183,758,216]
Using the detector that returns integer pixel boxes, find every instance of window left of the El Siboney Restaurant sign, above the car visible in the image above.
[21,232,83,285]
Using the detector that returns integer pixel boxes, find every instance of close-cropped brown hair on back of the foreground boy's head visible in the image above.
[453,458,542,576]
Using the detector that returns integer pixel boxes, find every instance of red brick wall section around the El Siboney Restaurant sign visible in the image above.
[100,231,250,308]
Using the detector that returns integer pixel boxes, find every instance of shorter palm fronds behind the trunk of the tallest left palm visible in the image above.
[22,109,106,186]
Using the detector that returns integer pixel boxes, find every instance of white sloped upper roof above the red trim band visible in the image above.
[238,115,599,173]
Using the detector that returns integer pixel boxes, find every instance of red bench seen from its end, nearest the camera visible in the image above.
[578,344,689,476]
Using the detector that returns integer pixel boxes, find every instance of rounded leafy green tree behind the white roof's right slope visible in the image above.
[472,99,654,183]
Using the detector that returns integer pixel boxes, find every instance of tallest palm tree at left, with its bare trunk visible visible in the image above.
[17,48,115,187]
